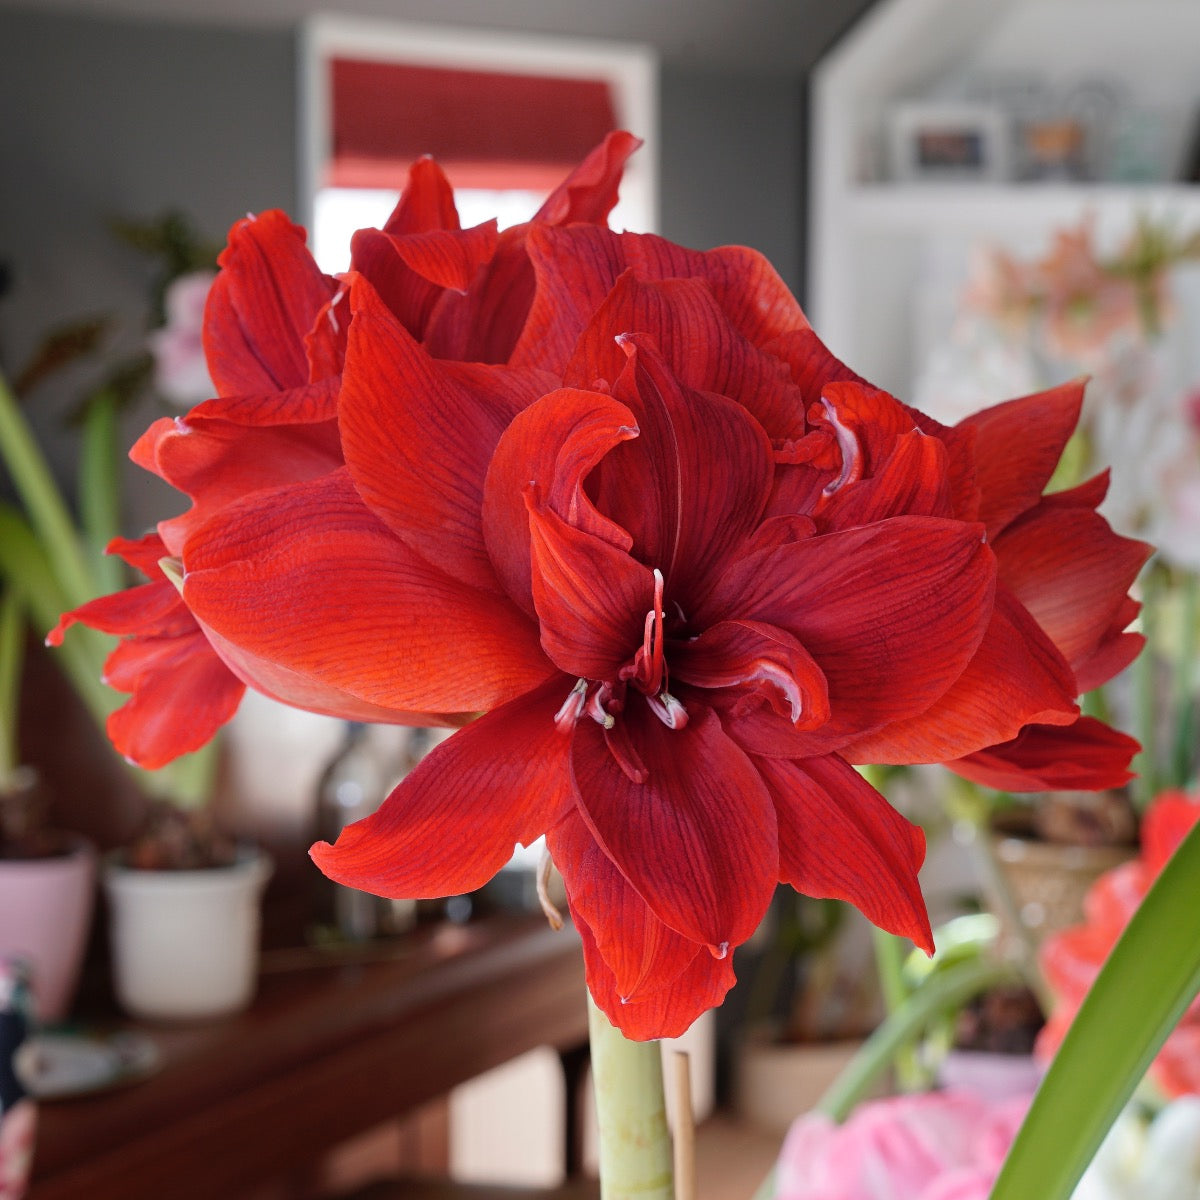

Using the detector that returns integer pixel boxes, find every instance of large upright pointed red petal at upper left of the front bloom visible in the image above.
[340,277,548,592]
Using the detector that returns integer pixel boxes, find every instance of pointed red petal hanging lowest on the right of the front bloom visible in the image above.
[757,755,934,954]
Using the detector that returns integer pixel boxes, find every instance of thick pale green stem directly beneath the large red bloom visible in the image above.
[588,995,674,1200]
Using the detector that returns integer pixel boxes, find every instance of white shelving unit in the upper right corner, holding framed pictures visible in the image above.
[806,0,1200,395]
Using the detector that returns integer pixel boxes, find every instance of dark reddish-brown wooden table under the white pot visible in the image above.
[30,914,587,1200]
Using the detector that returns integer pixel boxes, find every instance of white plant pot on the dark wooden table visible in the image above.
[104,852,272,1021]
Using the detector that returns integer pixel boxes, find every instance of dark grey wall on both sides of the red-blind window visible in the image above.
[0,8,802,508]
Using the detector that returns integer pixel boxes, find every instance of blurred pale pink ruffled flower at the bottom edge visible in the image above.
[775,1091,1030,1200]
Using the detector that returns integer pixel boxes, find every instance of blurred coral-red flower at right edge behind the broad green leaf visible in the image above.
[1037,791,1200,1097]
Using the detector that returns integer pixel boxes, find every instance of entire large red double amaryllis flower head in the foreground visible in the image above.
[54,134,1146,1038]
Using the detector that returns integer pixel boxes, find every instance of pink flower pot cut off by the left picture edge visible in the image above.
[0,838,96,1021]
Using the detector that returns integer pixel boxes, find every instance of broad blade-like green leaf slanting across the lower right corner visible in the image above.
[991,824,1200,1200]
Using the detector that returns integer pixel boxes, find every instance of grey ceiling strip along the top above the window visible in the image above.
[0,0,872,74]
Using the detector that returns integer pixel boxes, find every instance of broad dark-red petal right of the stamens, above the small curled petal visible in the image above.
[696,517,995,754]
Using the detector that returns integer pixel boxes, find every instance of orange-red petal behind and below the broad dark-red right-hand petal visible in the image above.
[841,587,1079,763]
